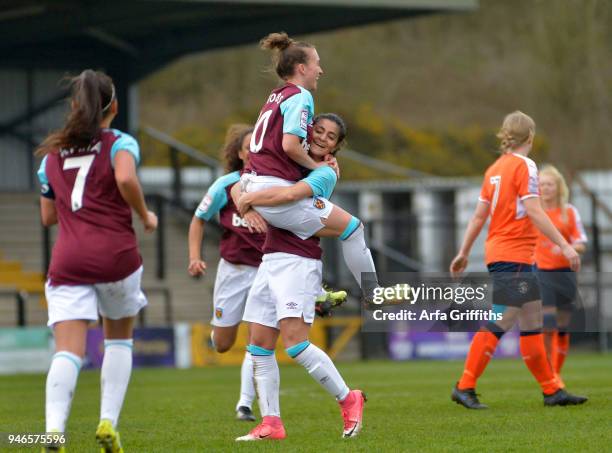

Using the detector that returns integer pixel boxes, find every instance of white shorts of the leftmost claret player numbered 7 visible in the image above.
[45,266,147,327]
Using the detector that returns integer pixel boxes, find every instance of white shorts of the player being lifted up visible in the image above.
[240,173,334,239]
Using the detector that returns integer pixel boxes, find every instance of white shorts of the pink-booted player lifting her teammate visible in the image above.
[243,253,322,329]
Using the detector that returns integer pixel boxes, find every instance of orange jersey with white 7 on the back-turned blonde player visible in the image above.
[478,153,540,264]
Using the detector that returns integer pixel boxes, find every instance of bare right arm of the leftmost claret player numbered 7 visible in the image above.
[114,150,157,233]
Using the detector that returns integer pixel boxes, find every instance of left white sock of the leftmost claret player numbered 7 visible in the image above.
[45,351,83,433]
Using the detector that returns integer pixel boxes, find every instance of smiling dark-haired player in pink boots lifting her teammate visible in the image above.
[233,110,365,440]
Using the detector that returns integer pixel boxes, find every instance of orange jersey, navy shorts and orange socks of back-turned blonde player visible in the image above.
[457,153,559,395]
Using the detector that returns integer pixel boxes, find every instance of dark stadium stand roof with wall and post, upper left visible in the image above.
[0,0,478,190]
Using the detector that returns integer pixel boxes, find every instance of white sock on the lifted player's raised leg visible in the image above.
[340,224,378,295]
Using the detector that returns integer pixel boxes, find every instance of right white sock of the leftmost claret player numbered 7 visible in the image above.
[100,339,134,427]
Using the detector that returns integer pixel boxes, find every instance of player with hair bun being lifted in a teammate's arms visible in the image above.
[242,33,378,300]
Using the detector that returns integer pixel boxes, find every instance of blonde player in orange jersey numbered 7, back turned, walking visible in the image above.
[450,111,587,409]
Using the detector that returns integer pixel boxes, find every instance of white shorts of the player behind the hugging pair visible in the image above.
[210,258,257,327]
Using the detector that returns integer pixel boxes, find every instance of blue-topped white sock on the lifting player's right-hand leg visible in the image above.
[287,341,349,401]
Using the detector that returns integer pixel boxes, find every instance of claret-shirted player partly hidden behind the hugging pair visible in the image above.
[188,124,266,421]
